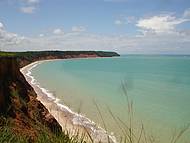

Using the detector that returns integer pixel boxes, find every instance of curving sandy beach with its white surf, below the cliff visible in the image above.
[20,59,116,143]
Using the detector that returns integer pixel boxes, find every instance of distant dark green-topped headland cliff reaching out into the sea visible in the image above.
[0,51,120,67]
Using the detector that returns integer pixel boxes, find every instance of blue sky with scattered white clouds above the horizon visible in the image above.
[0,0,190,55]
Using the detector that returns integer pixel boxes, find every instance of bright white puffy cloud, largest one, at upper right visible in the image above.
[136,15,188,33]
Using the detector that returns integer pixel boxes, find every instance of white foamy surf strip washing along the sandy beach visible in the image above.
[20,61,117,143]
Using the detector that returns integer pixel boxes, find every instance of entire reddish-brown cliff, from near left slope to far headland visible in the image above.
[0,51,119,143]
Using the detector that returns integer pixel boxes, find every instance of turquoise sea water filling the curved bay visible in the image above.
[32,56,190,143]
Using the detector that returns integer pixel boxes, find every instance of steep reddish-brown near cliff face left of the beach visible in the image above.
[0,57,61,141]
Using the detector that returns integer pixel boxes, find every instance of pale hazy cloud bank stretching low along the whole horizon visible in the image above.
[1,27,190,54]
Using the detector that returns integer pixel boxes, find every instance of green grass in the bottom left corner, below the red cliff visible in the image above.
[0,116,86,143]
